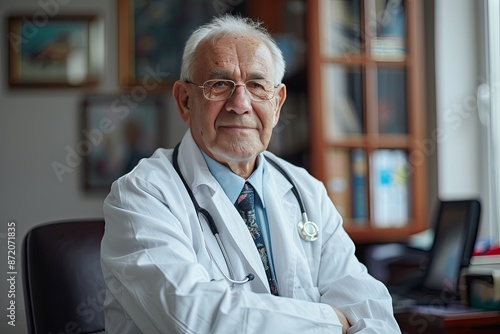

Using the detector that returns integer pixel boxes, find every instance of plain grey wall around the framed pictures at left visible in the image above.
[0,0,184,333]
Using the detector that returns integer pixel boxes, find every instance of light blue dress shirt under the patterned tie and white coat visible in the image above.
[200,150,279,284]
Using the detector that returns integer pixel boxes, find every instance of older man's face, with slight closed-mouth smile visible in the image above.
[174,35,286,172]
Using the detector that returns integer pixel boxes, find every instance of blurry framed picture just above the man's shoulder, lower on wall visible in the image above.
[81,93,167,191]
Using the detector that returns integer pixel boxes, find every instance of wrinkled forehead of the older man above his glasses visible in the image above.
[195,34,274,80]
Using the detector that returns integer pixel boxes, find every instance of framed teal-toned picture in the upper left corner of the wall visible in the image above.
[7,13,105,88]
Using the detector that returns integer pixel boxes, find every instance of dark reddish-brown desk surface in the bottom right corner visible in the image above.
[395,307,500,334]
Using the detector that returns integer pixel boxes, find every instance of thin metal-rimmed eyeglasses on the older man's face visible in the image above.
[186,79,279,101]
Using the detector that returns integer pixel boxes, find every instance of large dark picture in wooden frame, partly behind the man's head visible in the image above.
[118,0,245,87]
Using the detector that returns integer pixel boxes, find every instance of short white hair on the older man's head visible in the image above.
[180,14,285,84]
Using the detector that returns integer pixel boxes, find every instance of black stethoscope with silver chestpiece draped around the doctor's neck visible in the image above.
[173,144,319,285]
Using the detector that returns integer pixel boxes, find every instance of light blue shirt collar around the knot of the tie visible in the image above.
[200,150,265,206]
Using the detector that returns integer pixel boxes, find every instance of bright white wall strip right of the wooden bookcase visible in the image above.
[435,0,489,235]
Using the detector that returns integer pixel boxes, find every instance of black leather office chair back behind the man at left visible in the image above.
[22,220,106,334]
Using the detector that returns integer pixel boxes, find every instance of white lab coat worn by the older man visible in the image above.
[101,131,399,334]
